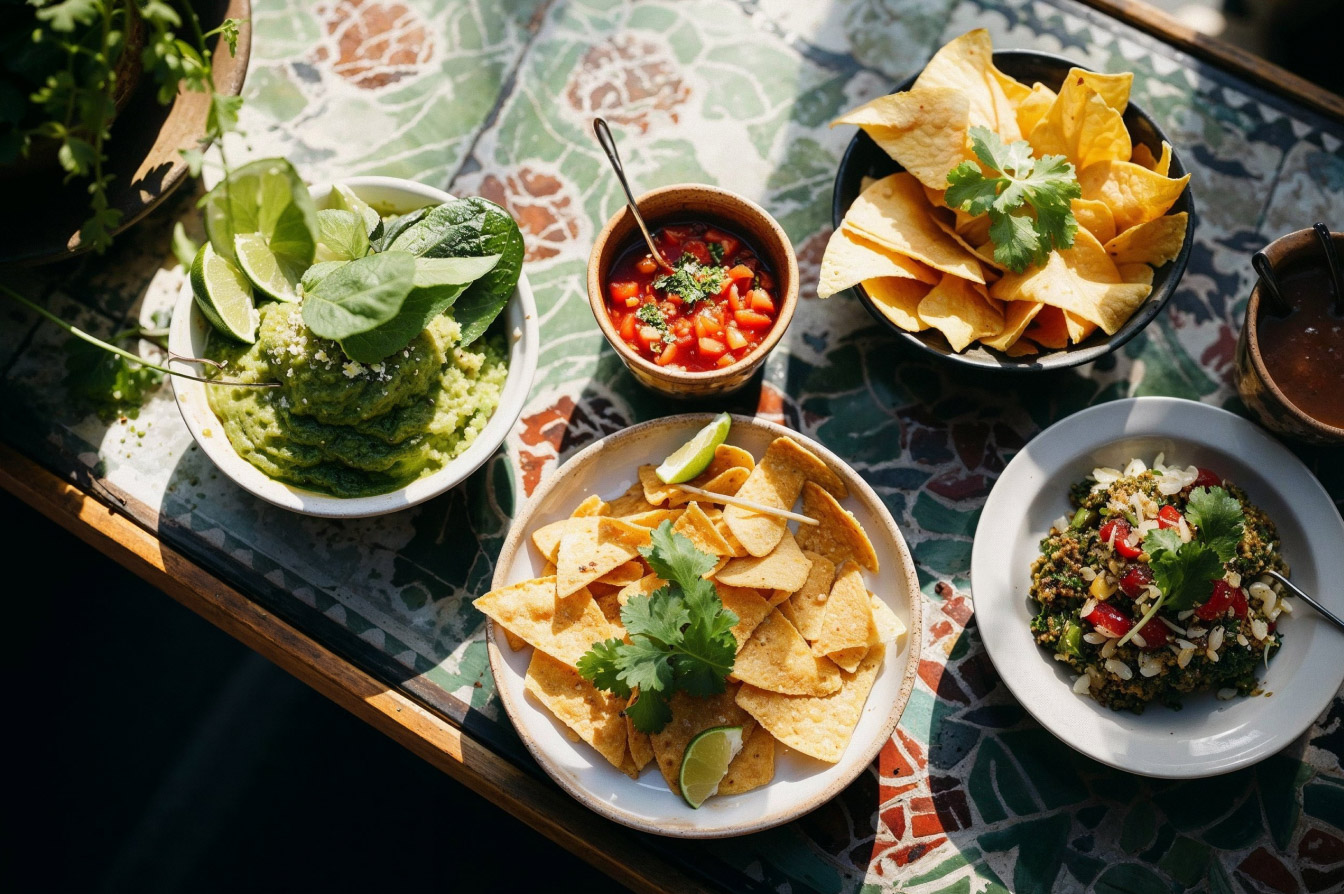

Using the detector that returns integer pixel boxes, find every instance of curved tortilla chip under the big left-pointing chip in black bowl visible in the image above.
[844,173,985,282]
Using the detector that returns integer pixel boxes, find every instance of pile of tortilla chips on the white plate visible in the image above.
[476,437,905,795]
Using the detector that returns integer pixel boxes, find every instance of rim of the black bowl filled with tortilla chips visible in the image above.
[831,50,1198,372]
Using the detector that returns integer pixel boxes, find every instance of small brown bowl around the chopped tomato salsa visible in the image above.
[589,183,798,398]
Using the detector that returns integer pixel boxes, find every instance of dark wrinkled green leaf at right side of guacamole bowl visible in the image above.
[392,196,523,346]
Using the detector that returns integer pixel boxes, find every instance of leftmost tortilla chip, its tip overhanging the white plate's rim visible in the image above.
[472,577,617,664]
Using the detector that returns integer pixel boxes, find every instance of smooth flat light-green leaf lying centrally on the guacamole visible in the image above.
[304,251,415,341]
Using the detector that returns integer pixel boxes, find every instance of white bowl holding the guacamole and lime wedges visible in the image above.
[168,177,539,519]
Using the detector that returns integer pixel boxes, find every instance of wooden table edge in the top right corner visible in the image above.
[1078,0,1344,121]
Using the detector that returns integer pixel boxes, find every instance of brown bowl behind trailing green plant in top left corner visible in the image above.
[0,0,251,265]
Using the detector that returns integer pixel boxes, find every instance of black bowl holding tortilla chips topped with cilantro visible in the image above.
[831,50,1195,372]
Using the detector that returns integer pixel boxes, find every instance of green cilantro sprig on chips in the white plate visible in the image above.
[578,522,738,733]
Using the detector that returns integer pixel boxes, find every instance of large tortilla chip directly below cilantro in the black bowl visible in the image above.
[989,227,1152,334]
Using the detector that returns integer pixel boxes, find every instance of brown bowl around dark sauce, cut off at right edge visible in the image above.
[1236,229,1344,446]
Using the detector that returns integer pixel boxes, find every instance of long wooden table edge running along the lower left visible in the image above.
[0,444,703,891]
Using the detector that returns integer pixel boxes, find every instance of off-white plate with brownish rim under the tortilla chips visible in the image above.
[488,414,922,838]
